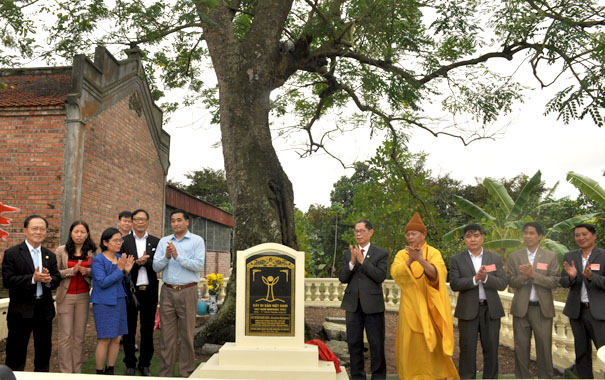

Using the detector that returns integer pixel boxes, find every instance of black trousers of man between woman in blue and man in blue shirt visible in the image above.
[124,286,158,368]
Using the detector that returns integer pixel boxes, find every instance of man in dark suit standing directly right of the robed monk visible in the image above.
[450,224,506,379]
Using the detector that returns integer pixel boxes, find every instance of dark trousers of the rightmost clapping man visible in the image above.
[569,306,605,379]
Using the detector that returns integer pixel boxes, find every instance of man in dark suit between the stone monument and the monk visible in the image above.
[338,219,389,380]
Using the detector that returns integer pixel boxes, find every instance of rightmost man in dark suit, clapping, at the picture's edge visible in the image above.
[561,224,605,379]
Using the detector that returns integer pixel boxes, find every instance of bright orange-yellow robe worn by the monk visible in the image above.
[391,243,460,380]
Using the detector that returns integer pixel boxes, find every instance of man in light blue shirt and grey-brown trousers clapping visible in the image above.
[153,209,206,377]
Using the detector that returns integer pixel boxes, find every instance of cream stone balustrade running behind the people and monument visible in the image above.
[0,278,605,378]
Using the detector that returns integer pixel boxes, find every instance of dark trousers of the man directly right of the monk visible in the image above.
[458,305,500,379]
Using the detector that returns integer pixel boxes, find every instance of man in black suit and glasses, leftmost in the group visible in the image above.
[2,215,61,372]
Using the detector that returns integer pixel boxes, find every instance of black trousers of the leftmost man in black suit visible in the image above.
[6,300,53,372]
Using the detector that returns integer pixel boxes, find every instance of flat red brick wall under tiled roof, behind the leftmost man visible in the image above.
[0,107,65,252]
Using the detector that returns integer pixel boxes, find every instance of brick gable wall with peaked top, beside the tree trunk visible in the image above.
[80,93,164,244]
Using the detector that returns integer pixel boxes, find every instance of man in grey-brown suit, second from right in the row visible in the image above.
[505,222,561,379]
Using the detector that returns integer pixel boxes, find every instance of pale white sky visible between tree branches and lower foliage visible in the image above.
[164,85,605,211]
